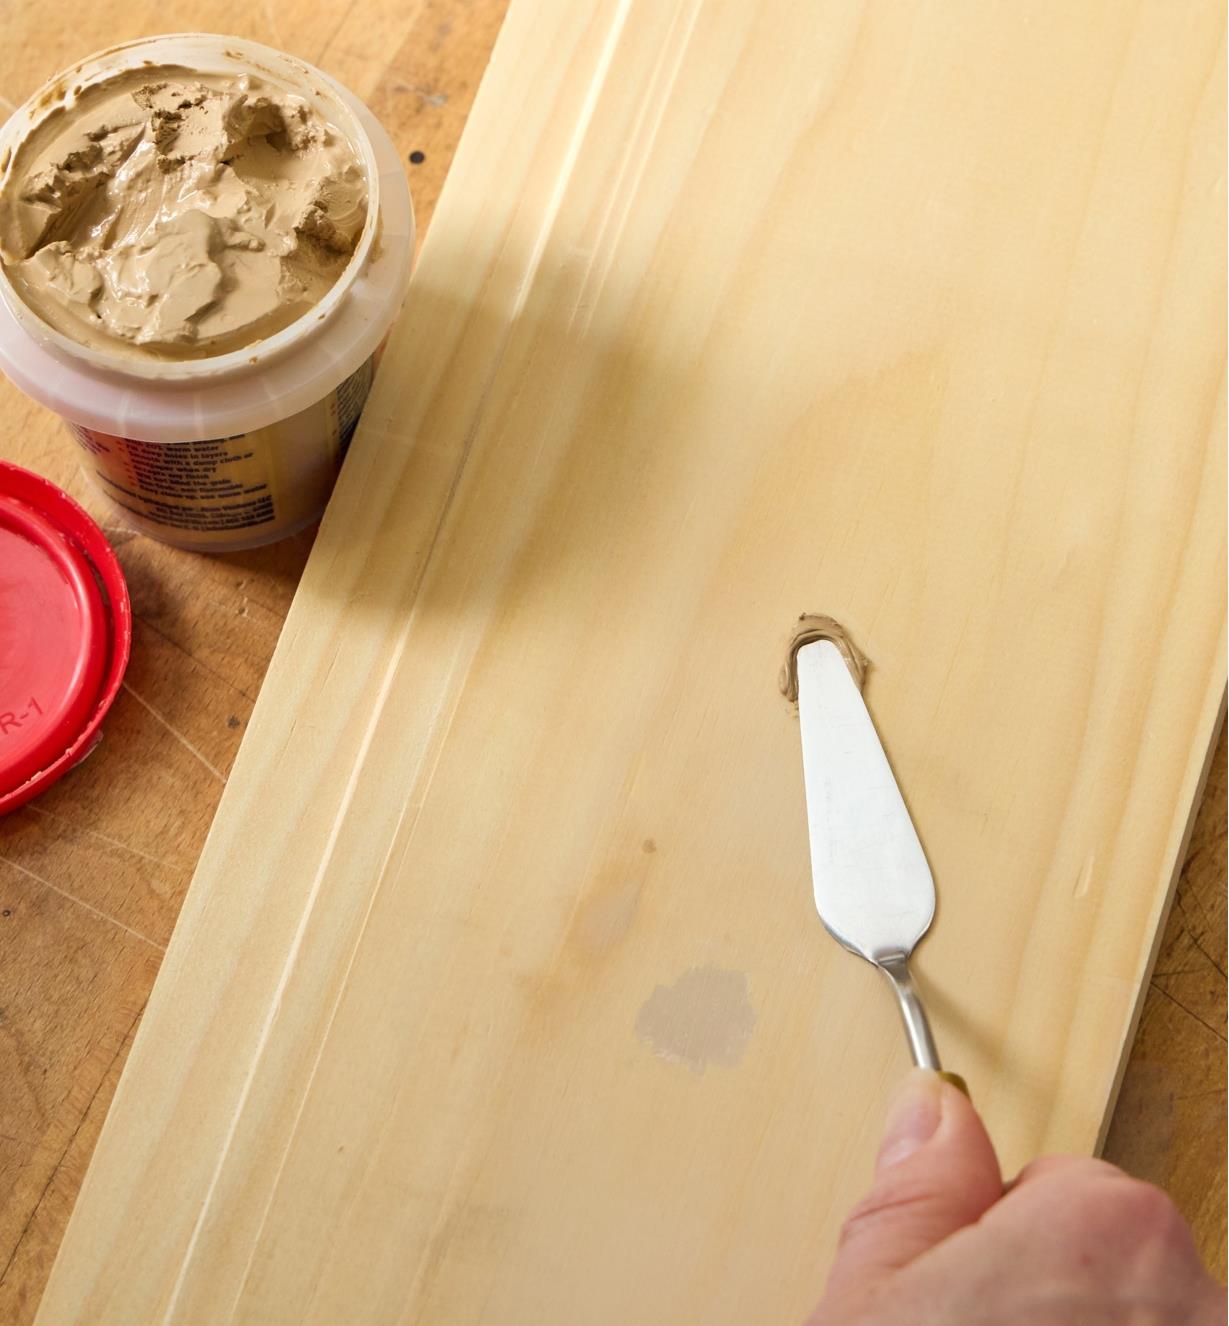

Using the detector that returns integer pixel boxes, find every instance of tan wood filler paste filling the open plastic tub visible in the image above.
[0,65,367,359]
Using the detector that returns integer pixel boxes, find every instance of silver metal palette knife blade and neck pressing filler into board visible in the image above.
[790,623,966,1090]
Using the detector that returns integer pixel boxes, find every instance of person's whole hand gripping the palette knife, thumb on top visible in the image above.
[809,1069,1226,1326]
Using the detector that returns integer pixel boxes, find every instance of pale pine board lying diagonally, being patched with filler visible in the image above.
[40,0,1225,1322]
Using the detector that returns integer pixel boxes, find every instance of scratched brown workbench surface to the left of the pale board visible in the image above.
[0,0,505,1326]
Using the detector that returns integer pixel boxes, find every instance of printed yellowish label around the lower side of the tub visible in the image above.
[69,359,374,548]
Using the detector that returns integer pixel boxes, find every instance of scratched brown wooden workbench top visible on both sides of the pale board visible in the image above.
[0,0,1225,1322]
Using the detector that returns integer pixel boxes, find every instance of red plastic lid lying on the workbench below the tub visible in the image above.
[0,461,133,814]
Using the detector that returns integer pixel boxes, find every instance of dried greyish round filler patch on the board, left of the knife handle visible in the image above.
[636,967,756,1075]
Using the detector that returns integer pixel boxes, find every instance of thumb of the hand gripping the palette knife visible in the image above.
[818,1069,1002,1321]
